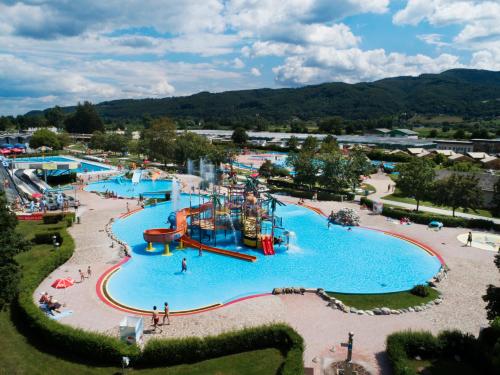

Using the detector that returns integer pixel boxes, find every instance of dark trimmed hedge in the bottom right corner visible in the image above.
[386,327,500,375]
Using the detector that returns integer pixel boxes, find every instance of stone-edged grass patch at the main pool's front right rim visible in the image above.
[328,288,439,310]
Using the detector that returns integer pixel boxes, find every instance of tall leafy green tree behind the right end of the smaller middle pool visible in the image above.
[142,117,176,165]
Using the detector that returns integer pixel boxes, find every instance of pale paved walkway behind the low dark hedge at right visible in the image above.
[366,173,500,224]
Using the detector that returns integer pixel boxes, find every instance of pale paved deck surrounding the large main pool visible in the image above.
[34,176,500,374]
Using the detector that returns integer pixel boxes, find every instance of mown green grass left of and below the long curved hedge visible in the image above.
[5,221,284,375]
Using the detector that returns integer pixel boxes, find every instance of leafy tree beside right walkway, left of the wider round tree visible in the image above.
[396,158,435,211]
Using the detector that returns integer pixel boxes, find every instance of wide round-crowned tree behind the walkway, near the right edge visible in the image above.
[431,173,483,216]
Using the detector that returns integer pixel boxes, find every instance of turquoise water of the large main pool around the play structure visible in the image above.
[107,195,441,310]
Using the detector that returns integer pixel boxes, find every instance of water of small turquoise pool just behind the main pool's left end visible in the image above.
[84,177,172,198]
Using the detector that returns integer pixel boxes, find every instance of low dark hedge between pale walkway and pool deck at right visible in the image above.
[360,197,500,231]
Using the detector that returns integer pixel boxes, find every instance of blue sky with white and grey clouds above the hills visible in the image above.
[0,0,500,115]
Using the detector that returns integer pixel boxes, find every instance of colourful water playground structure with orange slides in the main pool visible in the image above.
[143,178,289,262]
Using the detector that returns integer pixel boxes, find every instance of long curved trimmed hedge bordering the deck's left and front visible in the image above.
[14,220,304,375]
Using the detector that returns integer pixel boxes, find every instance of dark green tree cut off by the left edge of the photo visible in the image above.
[0,193,28,309]
